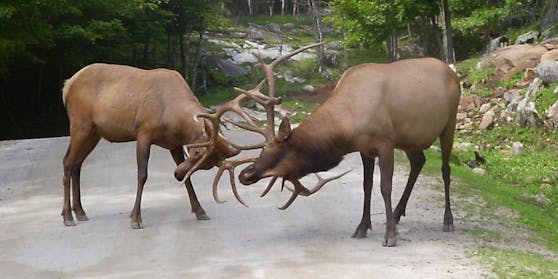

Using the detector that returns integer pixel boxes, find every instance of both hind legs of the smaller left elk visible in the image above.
[61,127,100,226]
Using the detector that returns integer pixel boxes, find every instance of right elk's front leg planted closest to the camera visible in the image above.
[379,148,397,247]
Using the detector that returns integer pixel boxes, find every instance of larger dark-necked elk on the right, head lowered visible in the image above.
[239,58,460,246]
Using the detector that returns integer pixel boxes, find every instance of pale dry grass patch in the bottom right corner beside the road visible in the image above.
[473,247,558,279]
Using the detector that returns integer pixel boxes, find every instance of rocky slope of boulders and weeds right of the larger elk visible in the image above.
[458,38,558,135]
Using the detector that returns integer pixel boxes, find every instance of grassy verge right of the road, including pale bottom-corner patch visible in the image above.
[423,145,558,278]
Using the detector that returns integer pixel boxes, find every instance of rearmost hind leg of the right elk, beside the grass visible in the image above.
[440,127,455,232]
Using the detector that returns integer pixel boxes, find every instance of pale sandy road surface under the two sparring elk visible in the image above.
[0,133,486,278]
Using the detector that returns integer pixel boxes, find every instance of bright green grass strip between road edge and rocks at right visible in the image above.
[424,139,558,255]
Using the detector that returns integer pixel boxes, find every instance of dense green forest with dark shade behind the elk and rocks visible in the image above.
[0,0,558,139]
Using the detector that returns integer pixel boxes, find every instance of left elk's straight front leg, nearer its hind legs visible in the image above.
[130,138,151,229]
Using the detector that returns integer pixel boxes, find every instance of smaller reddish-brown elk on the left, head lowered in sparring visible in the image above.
[61,63,239,229]
